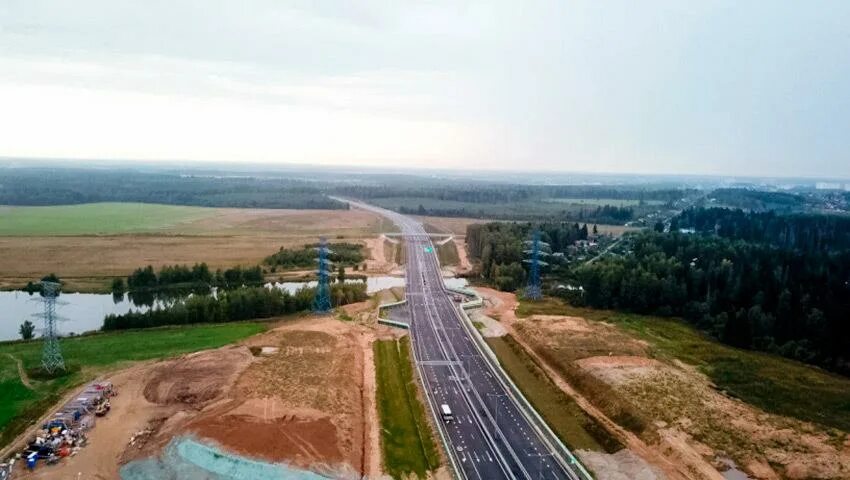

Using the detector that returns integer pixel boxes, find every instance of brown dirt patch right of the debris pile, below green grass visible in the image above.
[143,347,252,408]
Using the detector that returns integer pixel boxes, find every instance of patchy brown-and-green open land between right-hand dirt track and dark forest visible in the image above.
[512,299,850,479]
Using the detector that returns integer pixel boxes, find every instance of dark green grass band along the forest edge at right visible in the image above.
[517,298,850,431]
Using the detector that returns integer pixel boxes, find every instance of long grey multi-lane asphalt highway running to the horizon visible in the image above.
[338,200,589,480]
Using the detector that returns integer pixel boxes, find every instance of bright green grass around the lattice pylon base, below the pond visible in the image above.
[0,322,266,446]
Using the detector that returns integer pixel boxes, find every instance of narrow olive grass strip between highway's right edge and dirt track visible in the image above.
[486,335,623,453]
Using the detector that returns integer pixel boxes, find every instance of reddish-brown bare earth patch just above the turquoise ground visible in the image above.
[188,415,344,467]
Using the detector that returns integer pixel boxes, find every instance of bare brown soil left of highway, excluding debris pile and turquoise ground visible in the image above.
[14,310,394,479]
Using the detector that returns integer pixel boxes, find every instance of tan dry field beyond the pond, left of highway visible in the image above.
[0,204,383,291]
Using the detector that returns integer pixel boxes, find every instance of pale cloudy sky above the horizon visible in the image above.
[0,0,850,178]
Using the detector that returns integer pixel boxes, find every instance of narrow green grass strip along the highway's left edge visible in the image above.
[374,337,440,478]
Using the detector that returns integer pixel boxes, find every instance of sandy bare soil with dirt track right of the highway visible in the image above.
[477,288,850,480]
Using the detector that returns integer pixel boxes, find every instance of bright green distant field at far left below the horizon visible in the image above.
[0,203,217,235]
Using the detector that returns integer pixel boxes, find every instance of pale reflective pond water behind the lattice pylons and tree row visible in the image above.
[0,276,467,341]
